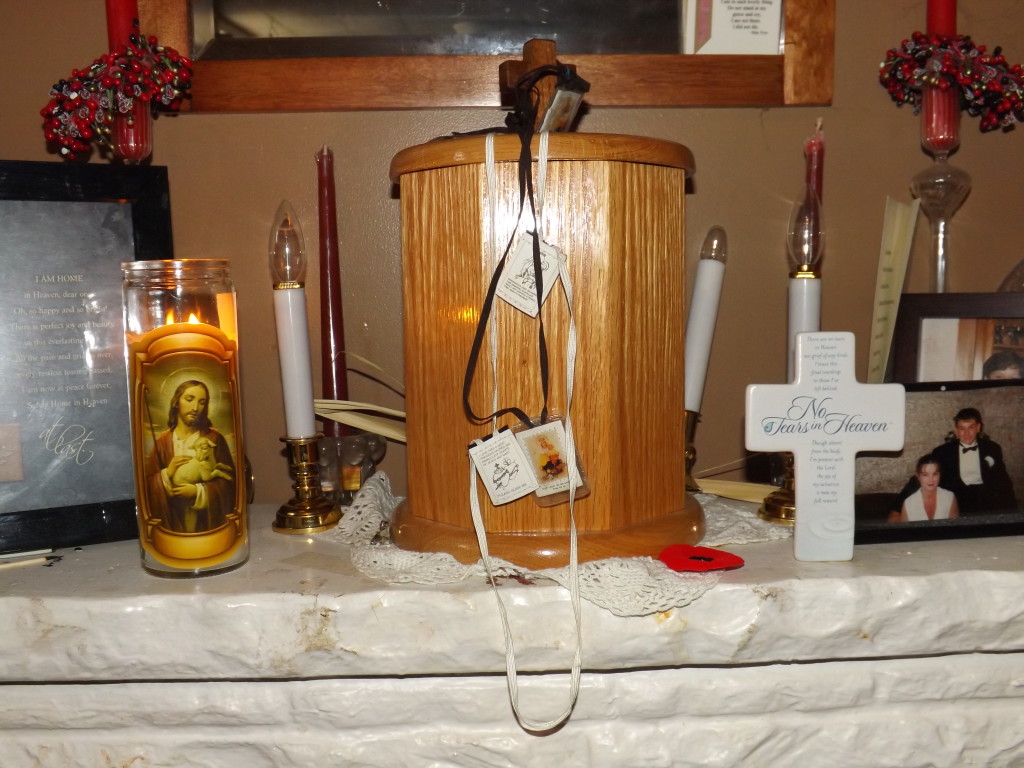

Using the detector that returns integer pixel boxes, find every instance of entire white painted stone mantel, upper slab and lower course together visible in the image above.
[0,506,1024,768]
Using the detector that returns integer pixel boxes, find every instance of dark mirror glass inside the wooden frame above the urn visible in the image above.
[191,0,688,60]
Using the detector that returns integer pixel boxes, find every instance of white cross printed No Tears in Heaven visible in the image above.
[746,333,906,560]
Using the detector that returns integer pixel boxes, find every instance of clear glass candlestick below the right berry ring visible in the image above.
[910,85,971,293]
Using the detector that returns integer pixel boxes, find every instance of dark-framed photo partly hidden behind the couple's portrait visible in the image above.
[891,293,1024,383]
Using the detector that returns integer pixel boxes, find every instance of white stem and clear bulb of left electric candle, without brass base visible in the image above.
[269,201,316,438]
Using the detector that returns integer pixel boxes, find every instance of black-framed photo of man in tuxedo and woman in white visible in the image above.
[855,379,1024,544]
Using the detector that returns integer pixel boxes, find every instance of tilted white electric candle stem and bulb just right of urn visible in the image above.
[683,226,727,414]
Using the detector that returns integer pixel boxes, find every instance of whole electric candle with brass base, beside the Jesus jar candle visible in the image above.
[269,201,341,534]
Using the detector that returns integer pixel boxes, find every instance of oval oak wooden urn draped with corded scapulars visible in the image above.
[390,133,703,568]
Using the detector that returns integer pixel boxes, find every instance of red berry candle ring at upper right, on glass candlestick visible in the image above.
[879,32,1024,133]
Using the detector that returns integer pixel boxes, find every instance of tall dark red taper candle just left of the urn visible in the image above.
[316,146,351,437]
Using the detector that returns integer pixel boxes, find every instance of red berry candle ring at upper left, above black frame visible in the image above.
[40,35,193,160]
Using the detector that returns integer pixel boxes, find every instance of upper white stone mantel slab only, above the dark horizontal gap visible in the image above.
[0,505,1024,683]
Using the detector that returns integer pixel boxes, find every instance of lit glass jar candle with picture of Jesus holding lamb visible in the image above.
[122,259,249,575]
